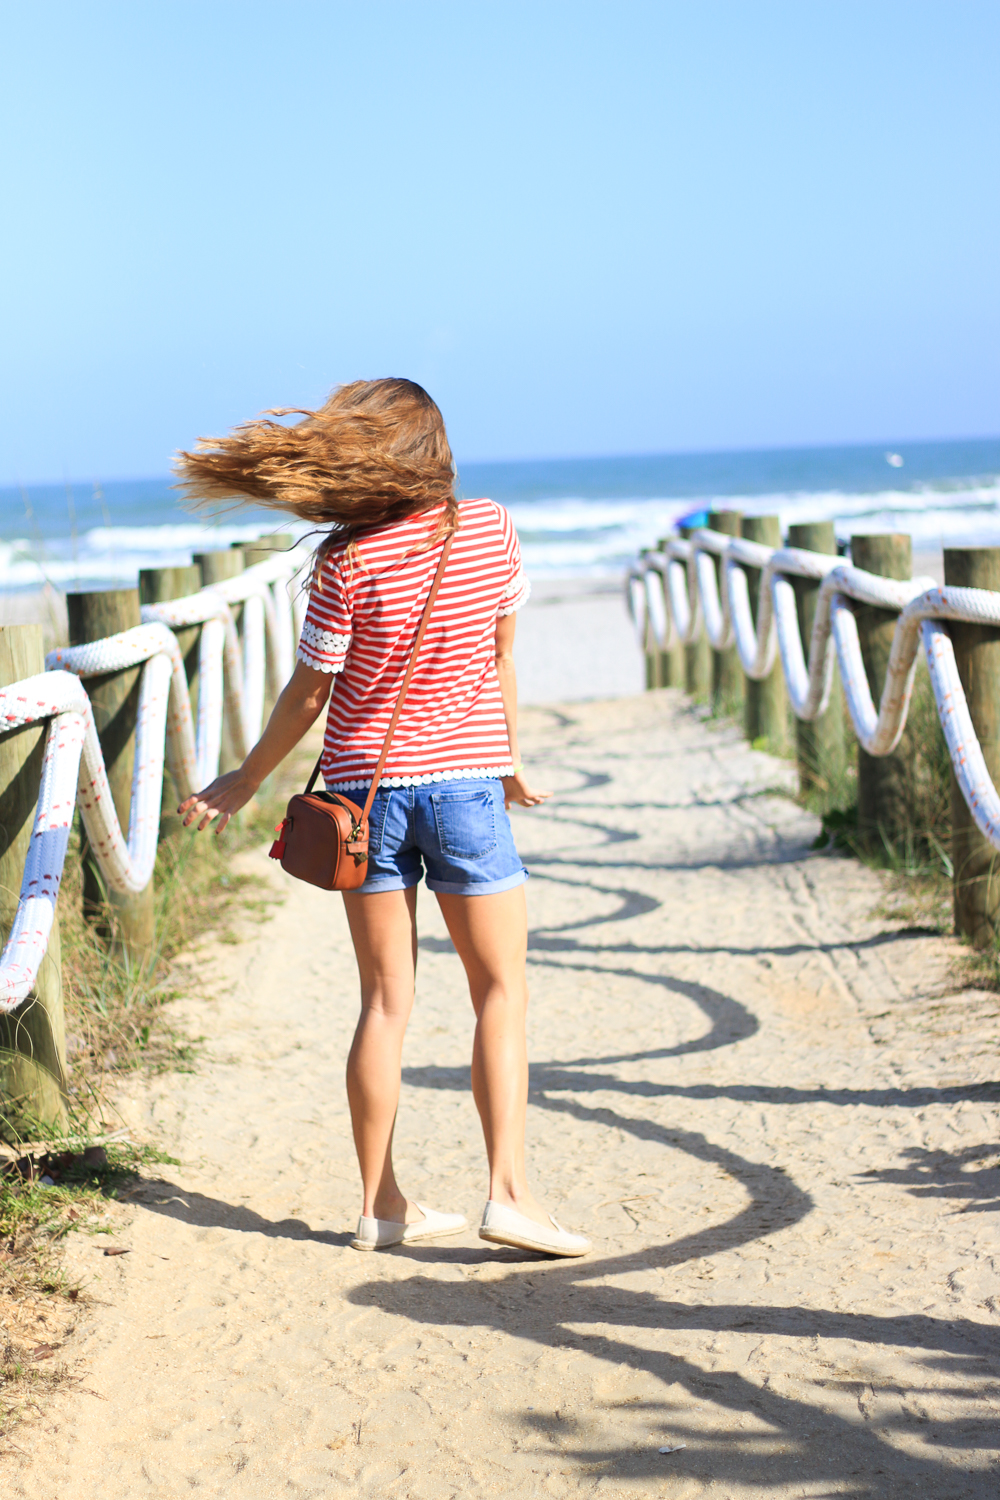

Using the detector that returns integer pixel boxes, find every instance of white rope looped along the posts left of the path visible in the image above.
[0,548,309,1011]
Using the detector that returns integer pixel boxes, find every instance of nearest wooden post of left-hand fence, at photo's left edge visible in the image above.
[0,626,66,1131]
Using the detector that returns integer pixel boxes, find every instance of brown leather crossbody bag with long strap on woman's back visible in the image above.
[270,534,454,891]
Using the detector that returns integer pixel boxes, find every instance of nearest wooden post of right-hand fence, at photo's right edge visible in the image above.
[945,548,1000,948]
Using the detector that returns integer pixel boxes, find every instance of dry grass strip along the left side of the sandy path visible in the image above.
[0,735,315,1443]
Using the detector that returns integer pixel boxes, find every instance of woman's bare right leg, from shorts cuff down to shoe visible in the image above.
[438,885,549,1226]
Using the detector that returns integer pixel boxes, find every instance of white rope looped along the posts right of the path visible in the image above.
[625,530,1000,851]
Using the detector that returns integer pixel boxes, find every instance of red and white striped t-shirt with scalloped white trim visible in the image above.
[298,500,529,791]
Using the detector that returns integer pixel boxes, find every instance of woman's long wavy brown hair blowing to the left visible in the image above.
[174,378,459,563]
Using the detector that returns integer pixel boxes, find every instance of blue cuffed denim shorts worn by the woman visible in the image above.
[330,777,528,896]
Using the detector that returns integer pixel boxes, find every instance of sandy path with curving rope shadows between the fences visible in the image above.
[4,693,1000,1500]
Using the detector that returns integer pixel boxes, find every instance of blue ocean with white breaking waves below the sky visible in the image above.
[0,438,1000,593]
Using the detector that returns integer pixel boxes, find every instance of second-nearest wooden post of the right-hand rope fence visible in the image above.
[850,533,915,849]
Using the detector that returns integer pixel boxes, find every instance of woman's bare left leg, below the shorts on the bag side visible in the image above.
[343,885,421,1223]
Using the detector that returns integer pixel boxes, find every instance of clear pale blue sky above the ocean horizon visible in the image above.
[0,0,1000,485]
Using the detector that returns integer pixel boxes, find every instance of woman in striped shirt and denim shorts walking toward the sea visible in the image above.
[178,380,591,1256]
